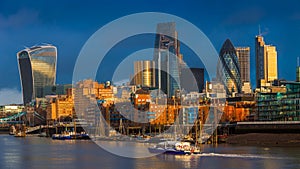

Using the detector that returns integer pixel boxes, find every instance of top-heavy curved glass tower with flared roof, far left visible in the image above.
[17,45,57,105]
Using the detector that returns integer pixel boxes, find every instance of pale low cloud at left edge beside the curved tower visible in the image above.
[0,88,23,105]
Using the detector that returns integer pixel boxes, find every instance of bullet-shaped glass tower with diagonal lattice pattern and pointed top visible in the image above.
[217,39,242,95]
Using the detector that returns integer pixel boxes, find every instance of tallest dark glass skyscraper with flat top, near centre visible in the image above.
[153,22,182,98]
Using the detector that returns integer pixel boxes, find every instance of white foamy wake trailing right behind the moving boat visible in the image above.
[197,153,286,159]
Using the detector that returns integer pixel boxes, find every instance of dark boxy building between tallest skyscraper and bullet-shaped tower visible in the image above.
[180,68,204,93]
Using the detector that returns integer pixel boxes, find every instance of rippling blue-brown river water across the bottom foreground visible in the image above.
[0,135,300,169]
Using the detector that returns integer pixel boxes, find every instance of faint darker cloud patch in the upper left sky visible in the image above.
[0,9,39,28]
